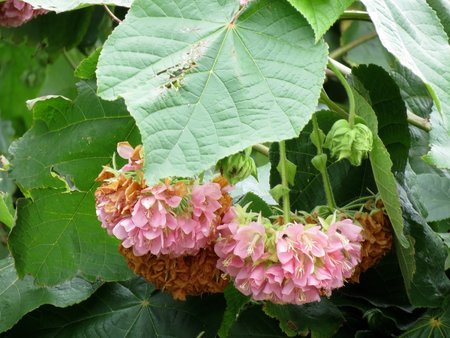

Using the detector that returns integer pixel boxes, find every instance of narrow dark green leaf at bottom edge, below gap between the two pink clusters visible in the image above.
[218,284,250,338]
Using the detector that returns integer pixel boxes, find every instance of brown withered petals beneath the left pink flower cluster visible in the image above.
[119,245,228,300]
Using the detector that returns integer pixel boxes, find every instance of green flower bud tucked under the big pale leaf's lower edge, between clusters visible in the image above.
[216,148,256,185]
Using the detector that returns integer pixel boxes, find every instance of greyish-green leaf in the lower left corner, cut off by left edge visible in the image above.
[0,258,101,332]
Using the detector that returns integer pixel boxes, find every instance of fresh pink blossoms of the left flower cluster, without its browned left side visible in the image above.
[112,182,222,257]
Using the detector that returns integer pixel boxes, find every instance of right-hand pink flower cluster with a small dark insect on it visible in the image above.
[214,209,363,304]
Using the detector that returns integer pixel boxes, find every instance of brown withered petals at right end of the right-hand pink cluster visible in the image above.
[350,209,392,283]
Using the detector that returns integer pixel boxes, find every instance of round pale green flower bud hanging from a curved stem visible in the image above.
[323,119,373,166]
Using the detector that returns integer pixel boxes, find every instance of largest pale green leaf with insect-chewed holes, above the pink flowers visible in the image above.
[97,0,327,182]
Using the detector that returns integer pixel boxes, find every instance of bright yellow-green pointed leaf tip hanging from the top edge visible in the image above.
[288,0,355,41]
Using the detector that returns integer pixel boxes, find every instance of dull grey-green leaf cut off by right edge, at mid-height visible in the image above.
[412,174,450,222]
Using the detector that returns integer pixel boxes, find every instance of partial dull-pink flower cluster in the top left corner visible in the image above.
[0,0,47,27]
